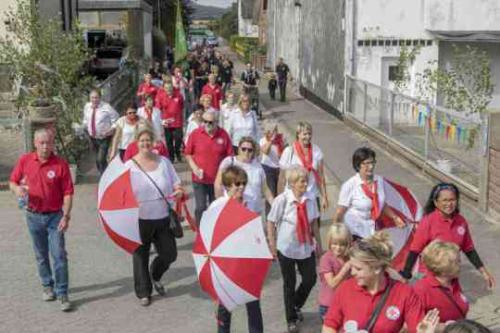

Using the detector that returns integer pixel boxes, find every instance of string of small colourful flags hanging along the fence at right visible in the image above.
[412,104,473,144]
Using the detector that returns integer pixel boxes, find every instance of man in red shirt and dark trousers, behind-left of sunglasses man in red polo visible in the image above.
[155,80,184,163]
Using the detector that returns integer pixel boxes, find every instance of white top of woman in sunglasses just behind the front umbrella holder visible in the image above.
[219,156,266,214]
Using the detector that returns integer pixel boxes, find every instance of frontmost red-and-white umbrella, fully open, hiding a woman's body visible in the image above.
[193,198,273,311]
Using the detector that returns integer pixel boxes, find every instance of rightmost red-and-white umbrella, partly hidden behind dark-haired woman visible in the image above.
[377,178,423,270]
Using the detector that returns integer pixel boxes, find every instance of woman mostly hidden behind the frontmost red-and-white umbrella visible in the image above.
[212,165,264,333]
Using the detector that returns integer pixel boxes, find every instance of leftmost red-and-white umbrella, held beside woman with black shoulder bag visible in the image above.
[97,156,141,253]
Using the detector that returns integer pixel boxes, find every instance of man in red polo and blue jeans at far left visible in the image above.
[9,129,74,311]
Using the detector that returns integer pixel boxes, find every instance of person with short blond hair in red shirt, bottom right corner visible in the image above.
[413,240,469,331]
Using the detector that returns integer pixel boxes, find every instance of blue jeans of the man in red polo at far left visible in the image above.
[26,211,68,296]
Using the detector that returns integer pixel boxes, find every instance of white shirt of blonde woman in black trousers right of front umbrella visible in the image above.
[267,189,320,259]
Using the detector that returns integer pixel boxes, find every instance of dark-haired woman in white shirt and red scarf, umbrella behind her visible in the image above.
[333,147,405,240]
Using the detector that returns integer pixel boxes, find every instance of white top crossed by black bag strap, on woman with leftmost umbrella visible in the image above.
[125,156,181,220]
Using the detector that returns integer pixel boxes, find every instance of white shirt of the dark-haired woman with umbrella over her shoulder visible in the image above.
[337,173,385,238]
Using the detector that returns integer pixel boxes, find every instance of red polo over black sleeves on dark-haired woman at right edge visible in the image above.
[410,209,474,253]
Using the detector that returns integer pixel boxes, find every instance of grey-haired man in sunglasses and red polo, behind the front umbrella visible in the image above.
[184,111,233,225]
